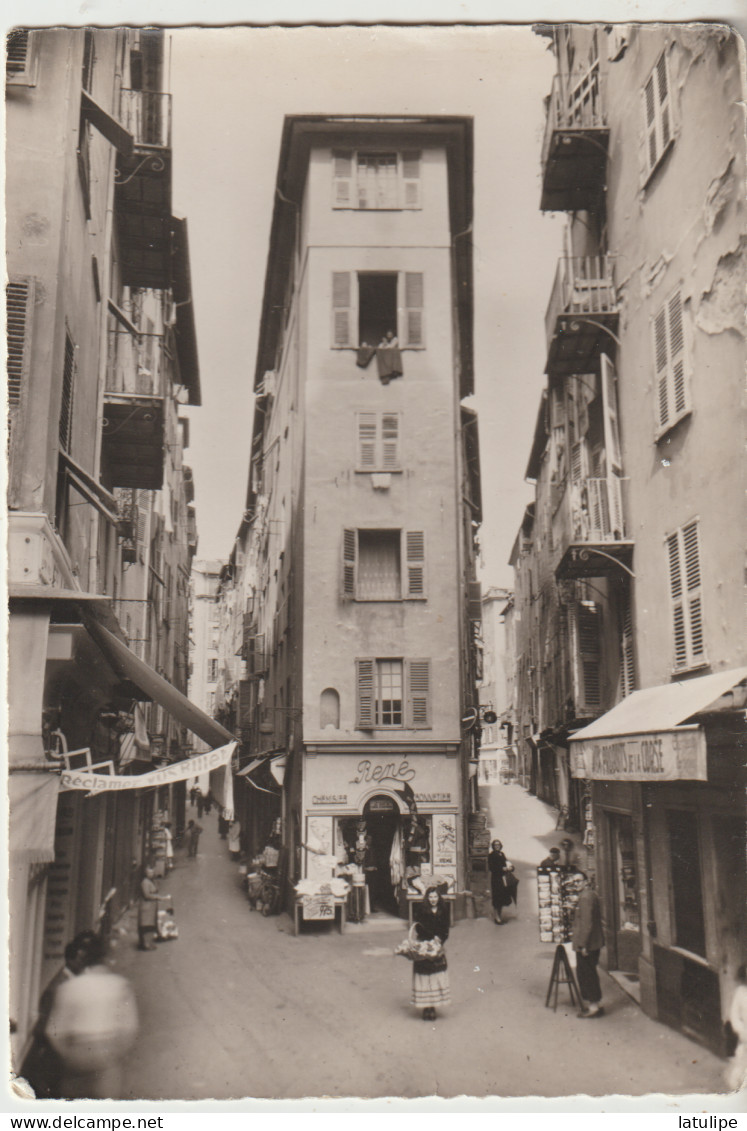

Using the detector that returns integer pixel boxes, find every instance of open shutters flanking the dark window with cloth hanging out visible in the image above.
[329,268,427,351]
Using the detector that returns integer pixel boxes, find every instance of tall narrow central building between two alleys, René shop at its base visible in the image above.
[207,115,481,922]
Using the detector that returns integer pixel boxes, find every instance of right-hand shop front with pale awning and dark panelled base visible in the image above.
[570,668,747,1054]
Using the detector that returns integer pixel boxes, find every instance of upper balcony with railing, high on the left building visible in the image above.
[114,90,172,290]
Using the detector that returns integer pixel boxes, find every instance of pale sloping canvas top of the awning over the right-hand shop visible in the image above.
[569,667,747,742]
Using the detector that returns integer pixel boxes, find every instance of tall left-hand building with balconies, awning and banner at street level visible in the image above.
[6,28,232,1070]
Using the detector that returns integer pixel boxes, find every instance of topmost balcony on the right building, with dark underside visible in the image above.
[540,63,610,211]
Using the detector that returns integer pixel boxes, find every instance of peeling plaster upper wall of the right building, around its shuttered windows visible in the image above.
[607,25,747,687]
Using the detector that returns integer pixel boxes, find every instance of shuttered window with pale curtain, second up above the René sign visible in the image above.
[342,529,426,601]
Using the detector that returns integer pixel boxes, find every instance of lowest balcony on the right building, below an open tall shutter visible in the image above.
[552,475,634,580]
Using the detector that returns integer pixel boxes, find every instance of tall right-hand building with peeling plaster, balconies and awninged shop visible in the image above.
[509,25,747,1053]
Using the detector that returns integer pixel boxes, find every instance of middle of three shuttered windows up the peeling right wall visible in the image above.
[651,284,693,443]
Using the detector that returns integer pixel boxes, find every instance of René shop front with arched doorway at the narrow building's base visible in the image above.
[302,748,464,917]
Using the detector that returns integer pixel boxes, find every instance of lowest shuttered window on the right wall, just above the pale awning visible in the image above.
[667,519,706,672]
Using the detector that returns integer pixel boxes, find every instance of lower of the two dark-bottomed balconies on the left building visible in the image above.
[102,329,168,491]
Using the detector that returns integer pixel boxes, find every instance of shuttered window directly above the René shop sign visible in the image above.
[355,658,431,731]
